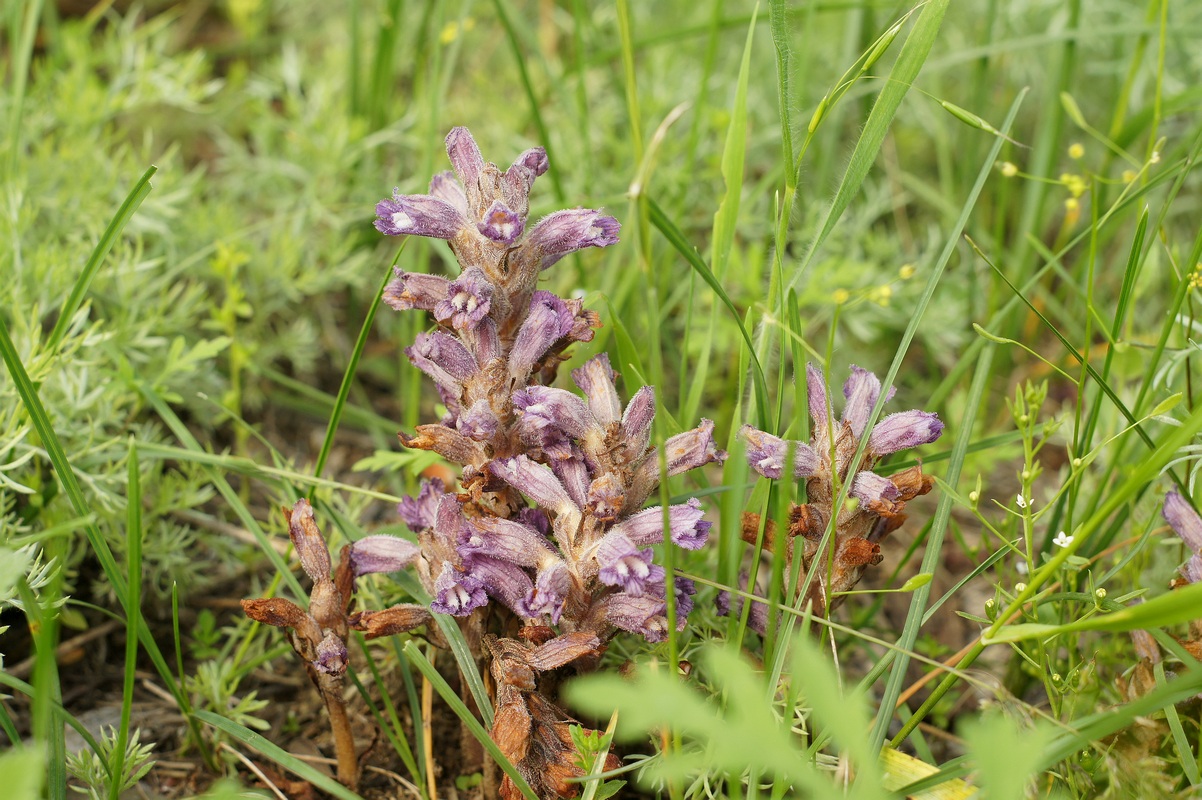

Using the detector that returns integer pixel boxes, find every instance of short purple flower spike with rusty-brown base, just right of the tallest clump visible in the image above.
[740,364,944,632]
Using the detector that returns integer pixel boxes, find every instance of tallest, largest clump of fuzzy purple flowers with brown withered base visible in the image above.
[365,127,726,796]
